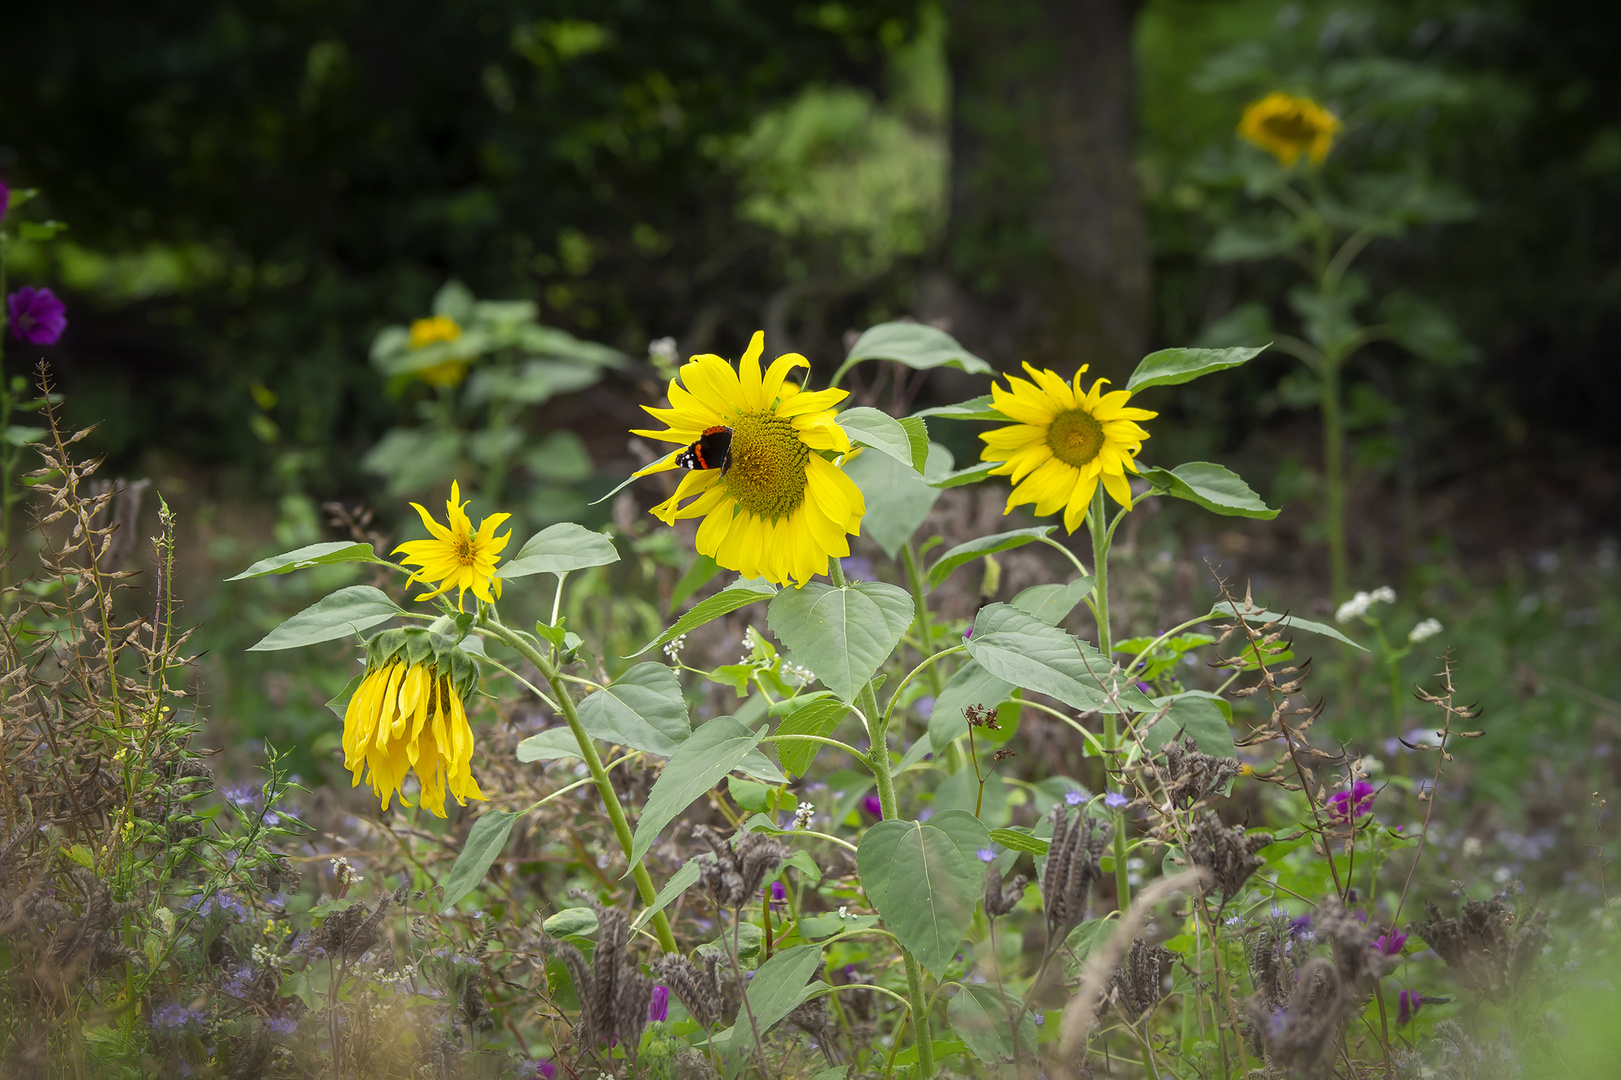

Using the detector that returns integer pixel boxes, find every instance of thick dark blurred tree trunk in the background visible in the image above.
[919,0,1149,378]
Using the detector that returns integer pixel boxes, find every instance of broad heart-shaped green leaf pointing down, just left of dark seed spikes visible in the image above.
[856,811,990,976]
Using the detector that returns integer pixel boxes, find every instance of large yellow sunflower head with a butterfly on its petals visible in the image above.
[634,332,867,585]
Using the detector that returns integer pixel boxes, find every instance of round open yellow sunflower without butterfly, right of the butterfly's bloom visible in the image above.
[979,363,1159,532]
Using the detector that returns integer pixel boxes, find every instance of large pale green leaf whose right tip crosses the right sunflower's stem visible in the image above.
[966,603,1153,712]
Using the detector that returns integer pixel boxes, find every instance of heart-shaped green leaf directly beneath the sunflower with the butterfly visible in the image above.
[767,581,913,702]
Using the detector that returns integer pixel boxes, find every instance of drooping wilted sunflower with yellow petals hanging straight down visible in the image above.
[344,628,485,817]
